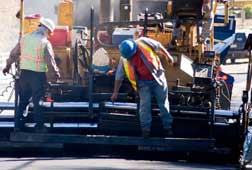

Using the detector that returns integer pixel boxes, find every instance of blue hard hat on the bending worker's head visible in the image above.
[120,39,137,59]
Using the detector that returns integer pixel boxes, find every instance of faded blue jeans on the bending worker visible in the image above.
[138,80,173,131]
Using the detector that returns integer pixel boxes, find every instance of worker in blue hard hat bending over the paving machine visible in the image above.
[111,37,173,137]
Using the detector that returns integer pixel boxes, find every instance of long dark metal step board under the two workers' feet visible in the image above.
[10,132,215,151]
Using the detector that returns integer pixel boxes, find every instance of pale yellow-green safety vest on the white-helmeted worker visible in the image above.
[20,34,47,72]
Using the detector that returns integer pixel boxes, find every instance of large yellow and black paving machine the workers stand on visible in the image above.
[0,0,251,167]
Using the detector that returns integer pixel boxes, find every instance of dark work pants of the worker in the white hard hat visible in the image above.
[15,70,46,127]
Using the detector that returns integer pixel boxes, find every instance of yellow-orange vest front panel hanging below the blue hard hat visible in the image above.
[122,58,137,91]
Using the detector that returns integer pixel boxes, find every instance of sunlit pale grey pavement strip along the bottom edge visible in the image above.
[0,157,238,170]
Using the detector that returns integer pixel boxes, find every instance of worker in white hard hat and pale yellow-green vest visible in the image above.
[3,18,60,132]
